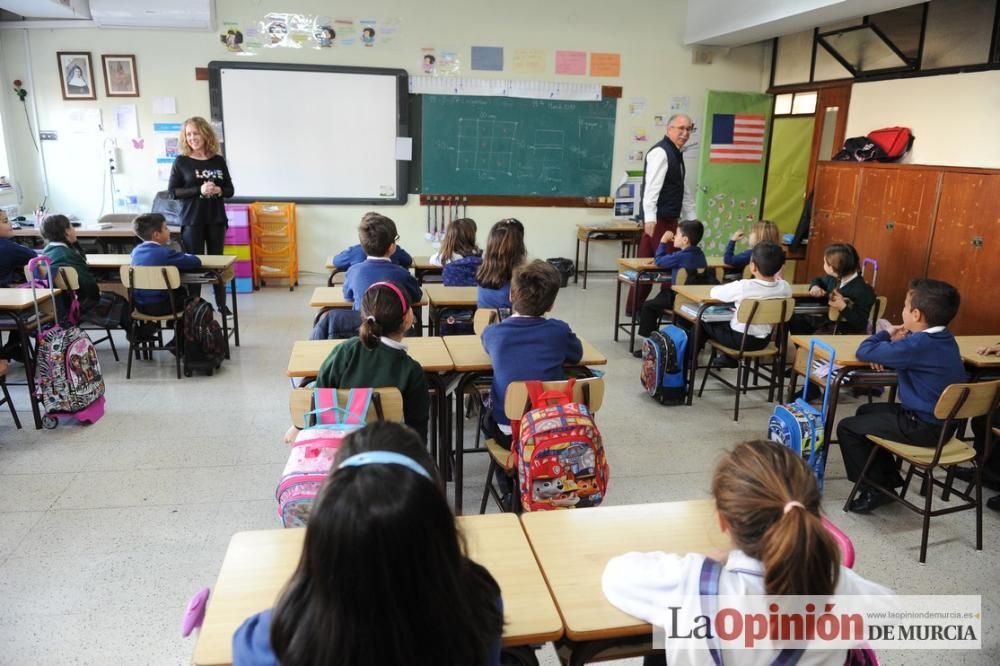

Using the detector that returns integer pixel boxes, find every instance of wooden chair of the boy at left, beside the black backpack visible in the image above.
[119,266,184,379]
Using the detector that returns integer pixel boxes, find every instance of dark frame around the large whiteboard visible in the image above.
[208,60,410,206]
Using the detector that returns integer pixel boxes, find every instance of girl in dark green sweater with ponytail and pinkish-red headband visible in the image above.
[316,282,430,441]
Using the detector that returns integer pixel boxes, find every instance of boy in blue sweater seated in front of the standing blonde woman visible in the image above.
[132,213,201,317]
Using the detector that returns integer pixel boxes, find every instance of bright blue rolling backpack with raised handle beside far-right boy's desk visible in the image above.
[767,340,835,494]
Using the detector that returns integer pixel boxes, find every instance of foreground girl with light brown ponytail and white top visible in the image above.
[602,441,892,666]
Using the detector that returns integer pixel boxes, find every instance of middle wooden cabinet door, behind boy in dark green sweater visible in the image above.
[854,168,942,324]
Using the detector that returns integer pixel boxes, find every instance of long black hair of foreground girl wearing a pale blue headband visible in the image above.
[271,422,503,666]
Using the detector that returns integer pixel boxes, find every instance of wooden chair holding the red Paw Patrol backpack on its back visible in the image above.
[479,377,604,513]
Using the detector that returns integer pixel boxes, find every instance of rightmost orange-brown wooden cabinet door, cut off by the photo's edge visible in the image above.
[927,173,1000,340]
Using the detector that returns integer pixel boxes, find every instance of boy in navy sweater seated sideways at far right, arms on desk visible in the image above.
[837,278,966,513]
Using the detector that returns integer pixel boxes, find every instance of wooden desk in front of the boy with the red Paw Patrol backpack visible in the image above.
[439,335,608,515]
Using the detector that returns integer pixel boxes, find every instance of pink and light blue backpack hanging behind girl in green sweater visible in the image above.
[275,388,382,527]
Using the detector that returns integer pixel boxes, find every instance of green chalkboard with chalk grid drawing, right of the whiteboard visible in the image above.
[420,95,617,197]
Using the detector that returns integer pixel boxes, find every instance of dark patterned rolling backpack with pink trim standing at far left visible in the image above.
[27,255,104,428]
